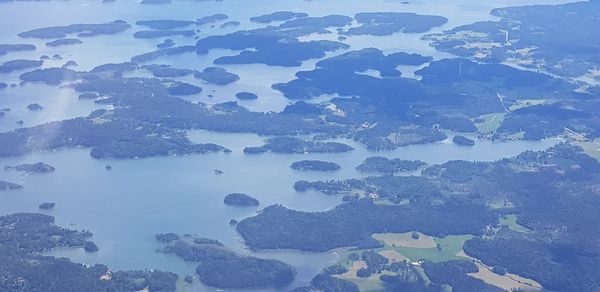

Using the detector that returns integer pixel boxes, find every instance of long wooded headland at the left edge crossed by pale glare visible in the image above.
[0,118,229,158]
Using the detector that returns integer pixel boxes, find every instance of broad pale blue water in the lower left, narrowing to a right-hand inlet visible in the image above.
[0,131,557,290]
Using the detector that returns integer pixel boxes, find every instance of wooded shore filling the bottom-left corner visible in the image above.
[0,213,178,292]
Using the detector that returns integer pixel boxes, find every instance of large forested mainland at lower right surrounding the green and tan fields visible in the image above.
[237,143,600,291]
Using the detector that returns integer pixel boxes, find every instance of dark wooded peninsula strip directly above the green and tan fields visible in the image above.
[237,199,497,251]
